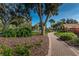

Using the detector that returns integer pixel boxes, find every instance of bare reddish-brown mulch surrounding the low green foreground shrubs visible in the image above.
[0,35,49,56]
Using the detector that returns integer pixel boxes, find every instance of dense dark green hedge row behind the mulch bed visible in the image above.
[3,28,32,37]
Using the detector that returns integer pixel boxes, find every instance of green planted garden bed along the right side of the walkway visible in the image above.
[55,32,79,46]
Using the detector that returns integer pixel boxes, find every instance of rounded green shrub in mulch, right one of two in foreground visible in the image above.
[15,45,31,56]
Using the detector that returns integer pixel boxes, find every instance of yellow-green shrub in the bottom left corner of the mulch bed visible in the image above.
[0,45,13,56]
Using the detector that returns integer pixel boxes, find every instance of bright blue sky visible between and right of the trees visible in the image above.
[32,3,79,27]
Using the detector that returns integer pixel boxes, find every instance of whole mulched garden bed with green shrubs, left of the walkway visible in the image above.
[0,35,49,56]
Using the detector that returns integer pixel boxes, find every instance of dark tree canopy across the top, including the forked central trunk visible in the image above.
[0,3,61,34]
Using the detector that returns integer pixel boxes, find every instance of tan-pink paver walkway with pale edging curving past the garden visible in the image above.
[48,33,76,56]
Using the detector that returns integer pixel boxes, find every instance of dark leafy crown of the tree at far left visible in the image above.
[0,3,31,31]
